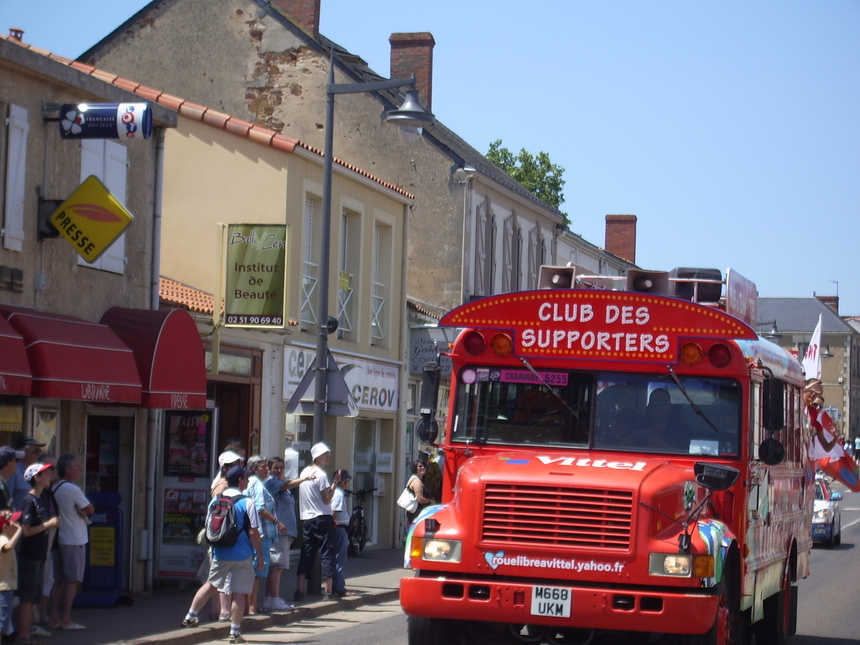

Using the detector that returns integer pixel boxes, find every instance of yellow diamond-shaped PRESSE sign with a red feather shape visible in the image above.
[50,175,134,262]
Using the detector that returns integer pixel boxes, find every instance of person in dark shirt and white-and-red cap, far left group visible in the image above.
[16,462,60,645]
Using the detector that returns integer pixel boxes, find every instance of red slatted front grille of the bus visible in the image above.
[481,483,633,551]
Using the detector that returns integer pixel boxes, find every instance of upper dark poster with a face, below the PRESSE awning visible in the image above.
[164,411,212,477]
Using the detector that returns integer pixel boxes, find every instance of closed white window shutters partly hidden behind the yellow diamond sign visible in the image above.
[78,139,128,273]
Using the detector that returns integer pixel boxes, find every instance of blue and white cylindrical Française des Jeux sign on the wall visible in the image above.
[60,103,152,139]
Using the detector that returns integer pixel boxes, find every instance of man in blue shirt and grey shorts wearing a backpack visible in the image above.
[182,466,263,643]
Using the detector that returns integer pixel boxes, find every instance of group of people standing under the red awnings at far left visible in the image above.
[0,437,95,645]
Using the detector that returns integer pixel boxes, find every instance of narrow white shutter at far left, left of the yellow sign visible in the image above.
[3,105,30,251]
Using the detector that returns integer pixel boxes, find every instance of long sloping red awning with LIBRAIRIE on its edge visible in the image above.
[0,305,140,403]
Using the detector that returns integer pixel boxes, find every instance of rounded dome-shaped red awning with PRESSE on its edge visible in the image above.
[99,307,206,410]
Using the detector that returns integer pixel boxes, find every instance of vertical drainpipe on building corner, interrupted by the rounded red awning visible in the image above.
[145,128,166,591]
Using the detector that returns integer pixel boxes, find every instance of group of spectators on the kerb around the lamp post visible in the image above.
[182,443,352,643]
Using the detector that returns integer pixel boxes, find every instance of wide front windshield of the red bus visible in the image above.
[451,366,741,457]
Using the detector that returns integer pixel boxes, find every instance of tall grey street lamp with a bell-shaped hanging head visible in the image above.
[313,64,435,443]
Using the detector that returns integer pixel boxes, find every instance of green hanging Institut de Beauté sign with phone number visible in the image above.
[224,224,287,327]
